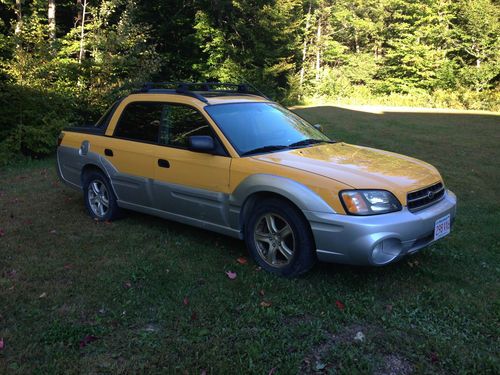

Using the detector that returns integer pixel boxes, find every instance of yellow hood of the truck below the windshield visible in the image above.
[254,143,441,203]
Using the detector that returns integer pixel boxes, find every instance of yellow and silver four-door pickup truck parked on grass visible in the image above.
[57,83,456,276]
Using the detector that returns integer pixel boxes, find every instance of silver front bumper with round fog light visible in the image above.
[304,190,457,265]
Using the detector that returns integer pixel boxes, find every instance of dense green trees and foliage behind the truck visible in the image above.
[0,0,500,160]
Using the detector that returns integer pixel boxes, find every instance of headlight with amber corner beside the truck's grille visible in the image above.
[339,190,401,215]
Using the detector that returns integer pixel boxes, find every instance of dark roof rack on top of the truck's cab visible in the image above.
[136,82,269,103]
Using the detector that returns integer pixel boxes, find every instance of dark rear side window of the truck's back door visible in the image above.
[114,102,164,143]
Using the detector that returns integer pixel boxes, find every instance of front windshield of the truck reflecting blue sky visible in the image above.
[205,103,330,156]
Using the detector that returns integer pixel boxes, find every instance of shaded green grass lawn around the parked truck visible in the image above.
[0,106,500,374]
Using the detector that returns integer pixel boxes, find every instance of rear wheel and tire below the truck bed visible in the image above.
[83,170,122,221]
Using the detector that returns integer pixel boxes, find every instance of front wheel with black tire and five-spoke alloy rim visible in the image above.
[244,198,316,277]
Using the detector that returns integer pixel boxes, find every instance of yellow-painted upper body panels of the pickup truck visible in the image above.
[62,93,441,213]
